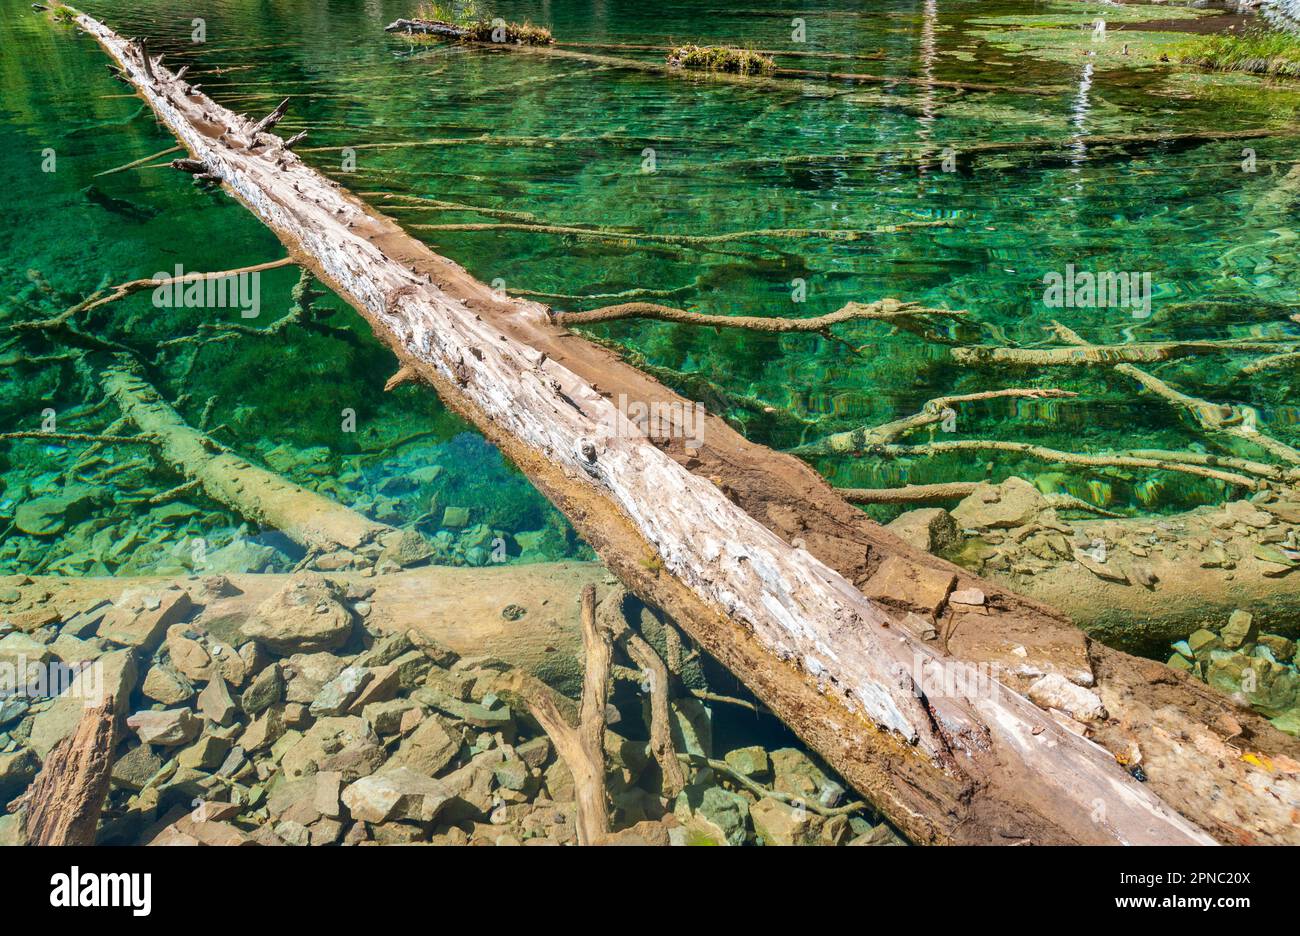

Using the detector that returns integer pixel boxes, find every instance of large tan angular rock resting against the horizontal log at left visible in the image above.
[241,572,352,657]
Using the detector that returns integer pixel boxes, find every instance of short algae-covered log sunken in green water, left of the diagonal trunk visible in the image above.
[101,367,400,564]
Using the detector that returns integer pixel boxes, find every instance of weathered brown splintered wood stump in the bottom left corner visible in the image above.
[23,696,117,845]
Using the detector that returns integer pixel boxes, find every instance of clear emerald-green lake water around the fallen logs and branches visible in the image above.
[0,0,1300,572]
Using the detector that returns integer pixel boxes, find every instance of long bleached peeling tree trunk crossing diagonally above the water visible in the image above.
[68,1,1300,844]
